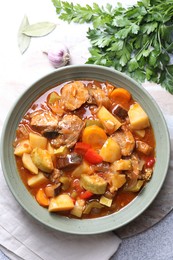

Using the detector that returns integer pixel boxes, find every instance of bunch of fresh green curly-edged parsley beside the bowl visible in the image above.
[52,0,173,94]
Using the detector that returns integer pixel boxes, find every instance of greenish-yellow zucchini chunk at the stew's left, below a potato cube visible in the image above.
[31,147,54,173]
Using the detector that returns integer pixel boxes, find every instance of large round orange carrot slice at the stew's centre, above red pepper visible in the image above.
[82,125,107,149]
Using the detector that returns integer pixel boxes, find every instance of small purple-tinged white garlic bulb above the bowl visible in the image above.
[44,42,70,68]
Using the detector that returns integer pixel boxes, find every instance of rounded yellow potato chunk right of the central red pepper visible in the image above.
[100,137,121,163]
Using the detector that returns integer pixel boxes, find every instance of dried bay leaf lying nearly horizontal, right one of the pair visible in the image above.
[22,22,56,37]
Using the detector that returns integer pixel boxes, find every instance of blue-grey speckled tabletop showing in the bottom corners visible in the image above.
[0,211,173,260]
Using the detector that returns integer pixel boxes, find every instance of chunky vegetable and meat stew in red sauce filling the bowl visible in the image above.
[14,80,156,218]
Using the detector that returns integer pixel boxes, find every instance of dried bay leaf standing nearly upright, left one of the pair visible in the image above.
[17,15,31,54]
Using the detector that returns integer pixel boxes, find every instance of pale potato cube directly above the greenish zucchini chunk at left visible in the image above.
[29,133,47,149]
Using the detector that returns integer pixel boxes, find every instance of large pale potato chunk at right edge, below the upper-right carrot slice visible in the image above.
[128,103,150,130]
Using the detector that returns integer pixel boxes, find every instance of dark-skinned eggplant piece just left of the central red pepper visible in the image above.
[56,153,82,169]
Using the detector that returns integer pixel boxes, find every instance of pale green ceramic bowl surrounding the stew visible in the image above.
[1,65,170,234]
